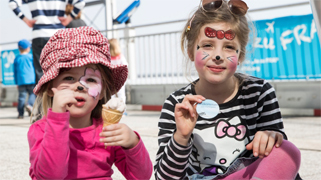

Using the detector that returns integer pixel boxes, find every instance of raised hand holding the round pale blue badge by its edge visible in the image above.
[174,95,205,146]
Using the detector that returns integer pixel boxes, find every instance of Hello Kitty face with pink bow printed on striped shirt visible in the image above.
[192,116,250,174]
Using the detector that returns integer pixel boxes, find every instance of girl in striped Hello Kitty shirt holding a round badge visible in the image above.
[154,0,301,180]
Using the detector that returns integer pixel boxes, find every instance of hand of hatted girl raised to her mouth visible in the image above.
[51,88,77,113]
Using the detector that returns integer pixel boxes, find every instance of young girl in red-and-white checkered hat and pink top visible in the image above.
[28,27,152,179]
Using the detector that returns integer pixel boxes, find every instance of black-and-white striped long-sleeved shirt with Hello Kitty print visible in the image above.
[154,73,286,179]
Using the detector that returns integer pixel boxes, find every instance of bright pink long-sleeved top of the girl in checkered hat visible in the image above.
[28,109,153,179]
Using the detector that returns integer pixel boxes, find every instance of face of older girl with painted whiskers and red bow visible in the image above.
[191,23,241,84]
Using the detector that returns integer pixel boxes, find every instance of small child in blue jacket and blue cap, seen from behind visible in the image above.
[13,39,36,119]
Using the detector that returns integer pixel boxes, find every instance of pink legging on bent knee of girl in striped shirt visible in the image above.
[220,140,301,180]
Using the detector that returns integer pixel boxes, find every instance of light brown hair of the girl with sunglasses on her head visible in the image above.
[181,3,250,62]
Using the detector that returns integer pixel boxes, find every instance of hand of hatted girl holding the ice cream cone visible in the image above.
[99,123,139,149]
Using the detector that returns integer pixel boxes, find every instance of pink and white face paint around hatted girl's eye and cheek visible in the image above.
[79,68,102,99]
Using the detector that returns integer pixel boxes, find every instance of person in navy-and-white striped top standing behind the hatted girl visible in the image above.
[9,0,85,83]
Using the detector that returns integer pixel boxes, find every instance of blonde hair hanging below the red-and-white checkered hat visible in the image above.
[30,64,116,123]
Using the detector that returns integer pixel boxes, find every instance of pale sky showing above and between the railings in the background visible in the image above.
[0,0,311,49]
